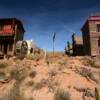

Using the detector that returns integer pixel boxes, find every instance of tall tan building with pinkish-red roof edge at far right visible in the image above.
[81,15,100,56]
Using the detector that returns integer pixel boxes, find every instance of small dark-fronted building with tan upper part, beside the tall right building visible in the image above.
[72,33,84,56]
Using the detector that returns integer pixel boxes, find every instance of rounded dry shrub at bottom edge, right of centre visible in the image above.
[54,89,70,100]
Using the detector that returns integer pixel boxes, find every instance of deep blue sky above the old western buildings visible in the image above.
[0,0,100,51]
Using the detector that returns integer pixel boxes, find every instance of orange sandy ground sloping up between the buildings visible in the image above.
[2,54,100,100]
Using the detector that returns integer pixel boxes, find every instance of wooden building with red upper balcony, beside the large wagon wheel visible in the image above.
[0,18,25,57]
